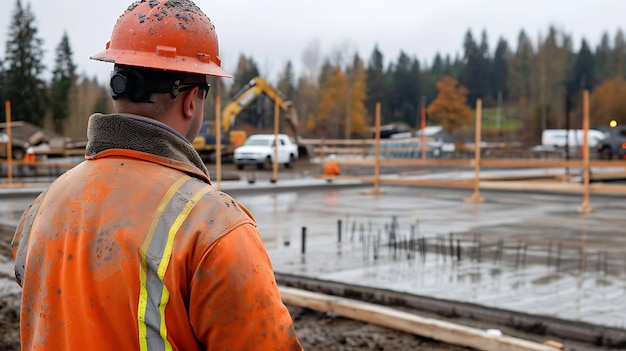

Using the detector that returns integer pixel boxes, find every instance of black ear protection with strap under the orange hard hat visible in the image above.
[109,65,184,103]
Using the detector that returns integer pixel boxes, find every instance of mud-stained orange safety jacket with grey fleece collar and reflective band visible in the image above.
[12,114,302,350]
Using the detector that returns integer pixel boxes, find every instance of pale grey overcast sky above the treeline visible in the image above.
[0,0,626,82]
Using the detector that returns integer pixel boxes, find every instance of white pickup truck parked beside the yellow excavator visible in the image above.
[234,134,298,170]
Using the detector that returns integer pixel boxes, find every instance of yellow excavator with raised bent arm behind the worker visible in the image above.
[193,77,300,160]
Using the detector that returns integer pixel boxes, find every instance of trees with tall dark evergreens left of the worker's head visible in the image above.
[0,0,112,137]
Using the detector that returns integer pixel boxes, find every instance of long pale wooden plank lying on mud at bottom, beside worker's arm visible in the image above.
[279,287,558,351]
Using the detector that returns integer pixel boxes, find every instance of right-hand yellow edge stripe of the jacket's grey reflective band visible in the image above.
[158,187,211,351]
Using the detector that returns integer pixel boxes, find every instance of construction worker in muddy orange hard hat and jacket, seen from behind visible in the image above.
[12,0,302,350]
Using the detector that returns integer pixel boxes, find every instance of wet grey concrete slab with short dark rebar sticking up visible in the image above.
[0,178,626,328]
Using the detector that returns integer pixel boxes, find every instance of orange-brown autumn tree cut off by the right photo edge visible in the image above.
[590,77,626,126]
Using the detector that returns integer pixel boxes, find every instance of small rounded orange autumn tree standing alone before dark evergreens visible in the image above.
[427,76,472,134]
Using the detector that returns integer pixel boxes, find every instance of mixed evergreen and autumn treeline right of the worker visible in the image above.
[222,27,626,141]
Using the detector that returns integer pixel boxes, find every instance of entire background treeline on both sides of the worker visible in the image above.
[0,0,626,145]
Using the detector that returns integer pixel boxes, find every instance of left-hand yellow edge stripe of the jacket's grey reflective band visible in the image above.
[137,176,190,351]
